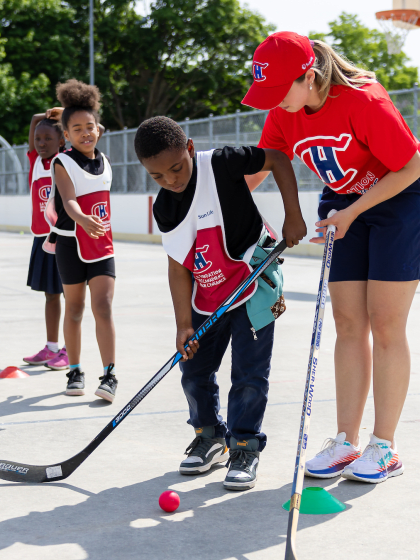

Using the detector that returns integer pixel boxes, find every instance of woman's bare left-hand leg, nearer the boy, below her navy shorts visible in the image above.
[329,281,372,446]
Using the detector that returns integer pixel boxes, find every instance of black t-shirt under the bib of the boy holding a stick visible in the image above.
[153,146,265,259]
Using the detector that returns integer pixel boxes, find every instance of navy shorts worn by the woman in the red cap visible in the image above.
[318,179,420,282]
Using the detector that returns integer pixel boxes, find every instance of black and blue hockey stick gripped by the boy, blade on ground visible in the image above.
[0,239,287,482]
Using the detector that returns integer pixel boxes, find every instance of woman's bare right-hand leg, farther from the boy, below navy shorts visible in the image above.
[367,280,418,442]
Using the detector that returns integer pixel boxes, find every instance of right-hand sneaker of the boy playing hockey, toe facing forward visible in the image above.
[223,437,260,490]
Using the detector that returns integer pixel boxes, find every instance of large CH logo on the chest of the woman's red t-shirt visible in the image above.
[293,134,357,190]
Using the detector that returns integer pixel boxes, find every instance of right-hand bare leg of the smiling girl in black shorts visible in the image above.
[89,276,115,367]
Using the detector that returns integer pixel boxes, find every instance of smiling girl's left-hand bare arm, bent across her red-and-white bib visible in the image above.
[54,164,106,239]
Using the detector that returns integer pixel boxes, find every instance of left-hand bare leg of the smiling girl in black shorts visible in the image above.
[63,282,86,365]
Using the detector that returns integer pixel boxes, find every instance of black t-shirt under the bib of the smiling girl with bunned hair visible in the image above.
[50,146,109,246]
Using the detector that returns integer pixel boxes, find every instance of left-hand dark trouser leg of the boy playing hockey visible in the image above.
[180,310,231,438]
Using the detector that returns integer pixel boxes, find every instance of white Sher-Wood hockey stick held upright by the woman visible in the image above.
[285,210,336,560]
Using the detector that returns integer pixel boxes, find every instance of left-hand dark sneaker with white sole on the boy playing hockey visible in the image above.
[179,426,229,474]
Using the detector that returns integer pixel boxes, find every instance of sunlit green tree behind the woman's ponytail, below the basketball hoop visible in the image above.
[309,12,418,90]
